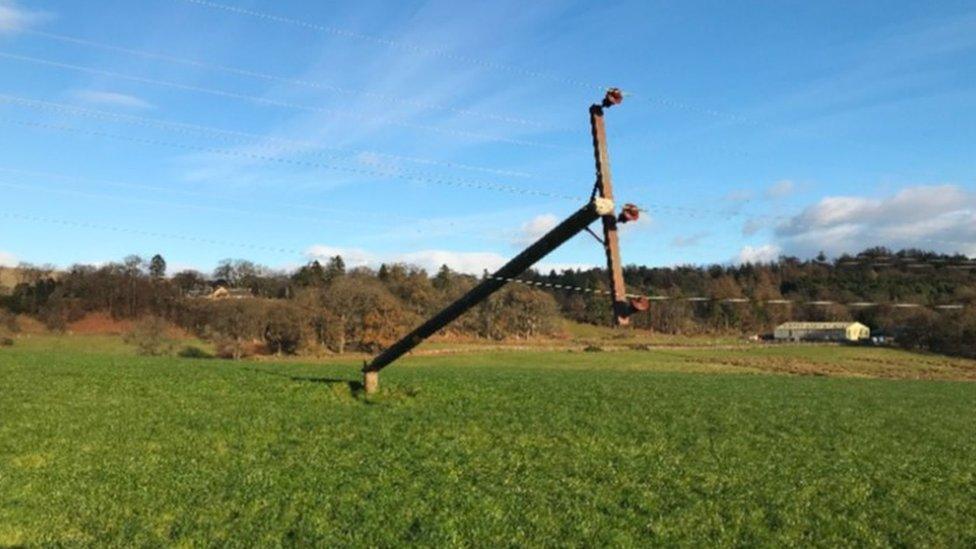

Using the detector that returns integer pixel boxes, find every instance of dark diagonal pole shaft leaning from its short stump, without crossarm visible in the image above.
[363,197,614,376]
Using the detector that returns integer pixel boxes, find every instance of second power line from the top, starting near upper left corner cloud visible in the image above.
[22,29,552,131]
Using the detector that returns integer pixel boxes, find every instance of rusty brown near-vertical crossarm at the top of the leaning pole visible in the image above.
[590,89,632,326]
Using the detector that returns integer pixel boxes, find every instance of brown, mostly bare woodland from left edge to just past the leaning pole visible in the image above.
[0,255,559,358]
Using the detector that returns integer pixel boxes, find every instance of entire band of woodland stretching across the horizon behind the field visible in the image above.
[0,248,976,357]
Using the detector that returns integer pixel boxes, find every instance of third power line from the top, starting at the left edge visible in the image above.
[0,52,573,150]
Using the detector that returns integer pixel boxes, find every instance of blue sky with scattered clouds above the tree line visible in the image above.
[0,0,976,273]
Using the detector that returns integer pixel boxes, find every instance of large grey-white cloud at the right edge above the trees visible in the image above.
[775,185,976,256]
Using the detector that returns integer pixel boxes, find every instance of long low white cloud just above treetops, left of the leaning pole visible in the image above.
[305,245,507,274]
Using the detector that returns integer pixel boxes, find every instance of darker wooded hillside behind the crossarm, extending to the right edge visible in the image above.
[525,247,976,357]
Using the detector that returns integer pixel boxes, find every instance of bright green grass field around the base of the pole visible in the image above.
[0,337,976,546]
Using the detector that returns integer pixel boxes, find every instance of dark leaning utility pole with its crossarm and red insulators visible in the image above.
[363,88,648,393]
